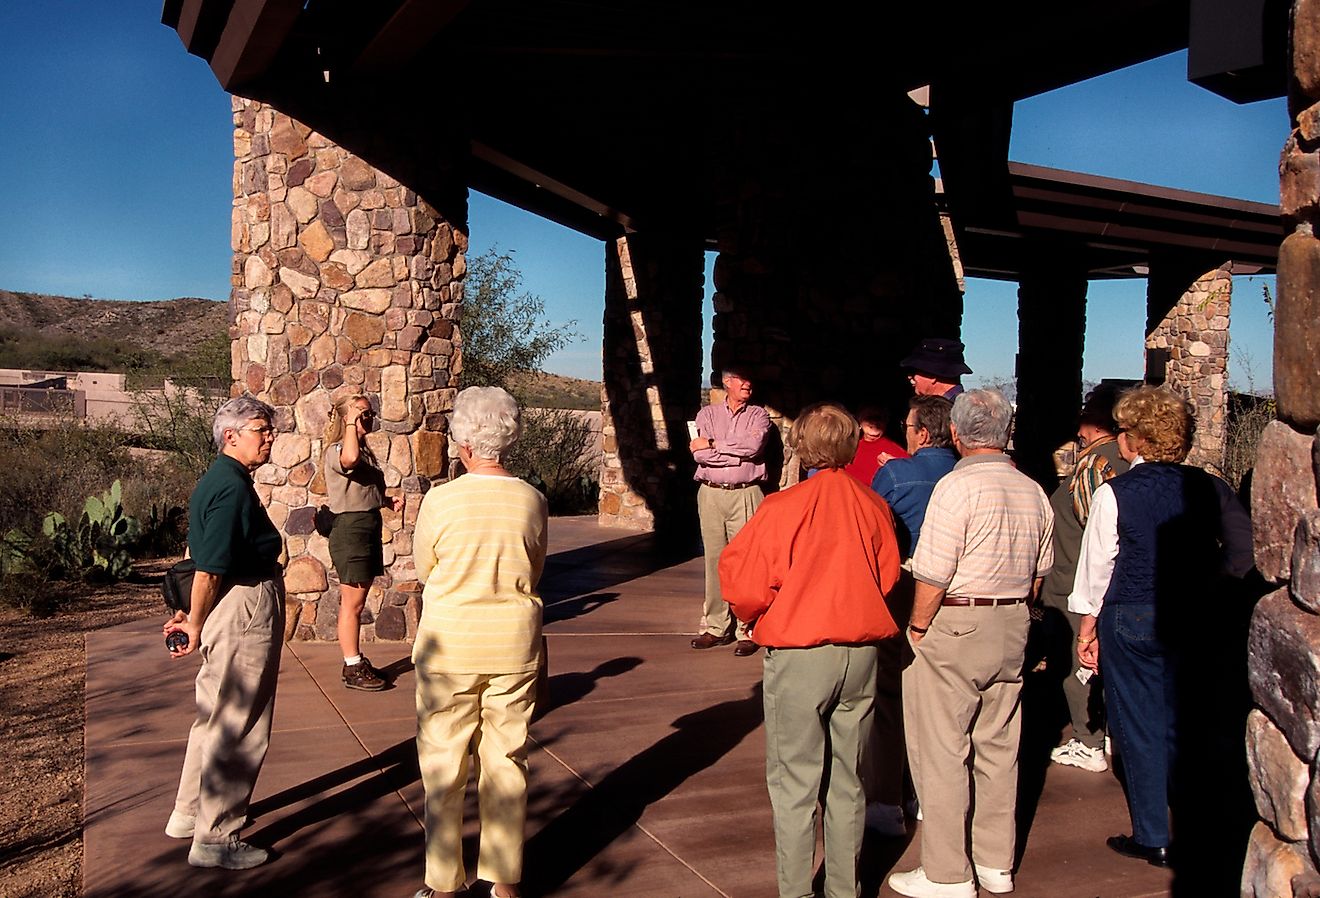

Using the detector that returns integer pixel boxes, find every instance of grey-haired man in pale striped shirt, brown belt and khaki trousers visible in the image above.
[890,390,1053,898]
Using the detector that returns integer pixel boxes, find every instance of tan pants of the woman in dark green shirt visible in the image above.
[174,580,284,843]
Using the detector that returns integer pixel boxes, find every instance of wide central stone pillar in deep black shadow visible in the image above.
[711,88,962,485]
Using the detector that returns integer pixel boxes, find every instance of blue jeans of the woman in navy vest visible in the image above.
[1098,602,1177,848]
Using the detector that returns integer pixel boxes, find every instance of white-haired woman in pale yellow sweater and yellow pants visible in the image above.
[413,387,548,898]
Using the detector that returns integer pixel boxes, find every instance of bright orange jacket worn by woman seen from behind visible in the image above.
[719,469,899,648]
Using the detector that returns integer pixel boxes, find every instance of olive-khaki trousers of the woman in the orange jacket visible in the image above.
[763,646,875,898]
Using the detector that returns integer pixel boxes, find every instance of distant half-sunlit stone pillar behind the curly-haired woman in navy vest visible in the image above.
[1146,263,1233,474]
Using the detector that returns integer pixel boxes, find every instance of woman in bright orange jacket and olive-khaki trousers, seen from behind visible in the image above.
[719,404,899,898]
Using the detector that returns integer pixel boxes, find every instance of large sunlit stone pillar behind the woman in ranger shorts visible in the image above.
[230,98,467,640]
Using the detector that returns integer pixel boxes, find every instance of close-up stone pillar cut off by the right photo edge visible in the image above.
[1242,0,1320,898]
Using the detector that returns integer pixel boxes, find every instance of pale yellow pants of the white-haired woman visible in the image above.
[417,660,536,891]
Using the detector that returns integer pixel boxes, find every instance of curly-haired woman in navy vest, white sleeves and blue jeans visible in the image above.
[1068,387,1251,866]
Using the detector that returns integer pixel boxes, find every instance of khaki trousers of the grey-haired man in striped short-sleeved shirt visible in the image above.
[903,602,1028,882]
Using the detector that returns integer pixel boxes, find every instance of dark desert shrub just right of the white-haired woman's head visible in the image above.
[504,408,601,515]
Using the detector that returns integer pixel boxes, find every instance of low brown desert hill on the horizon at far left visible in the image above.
[0,289,228,355]
